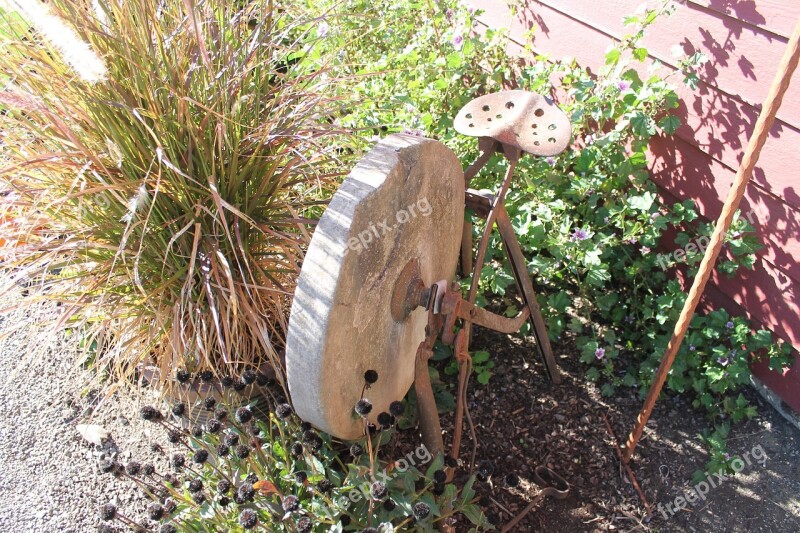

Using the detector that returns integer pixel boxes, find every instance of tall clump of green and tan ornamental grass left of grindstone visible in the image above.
[0,0,338,381]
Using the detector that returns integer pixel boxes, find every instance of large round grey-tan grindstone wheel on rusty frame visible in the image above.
[286,135,464,440]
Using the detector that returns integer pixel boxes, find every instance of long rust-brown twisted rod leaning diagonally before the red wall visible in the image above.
[624,13,800,464]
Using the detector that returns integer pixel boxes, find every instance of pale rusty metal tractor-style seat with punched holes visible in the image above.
[453,90,572,156]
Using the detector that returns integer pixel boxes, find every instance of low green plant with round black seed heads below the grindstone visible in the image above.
[100,374,488,533]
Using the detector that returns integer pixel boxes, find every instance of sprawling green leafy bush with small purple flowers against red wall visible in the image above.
[302,0,791,476]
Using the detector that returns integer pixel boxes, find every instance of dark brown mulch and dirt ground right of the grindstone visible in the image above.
[443,320,800,533]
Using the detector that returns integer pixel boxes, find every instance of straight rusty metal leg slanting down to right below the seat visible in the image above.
[495,205,561,384]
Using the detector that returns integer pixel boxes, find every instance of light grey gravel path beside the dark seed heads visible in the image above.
[0,285,164,533]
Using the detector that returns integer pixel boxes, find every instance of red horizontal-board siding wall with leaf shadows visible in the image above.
[465,0,800,411]
